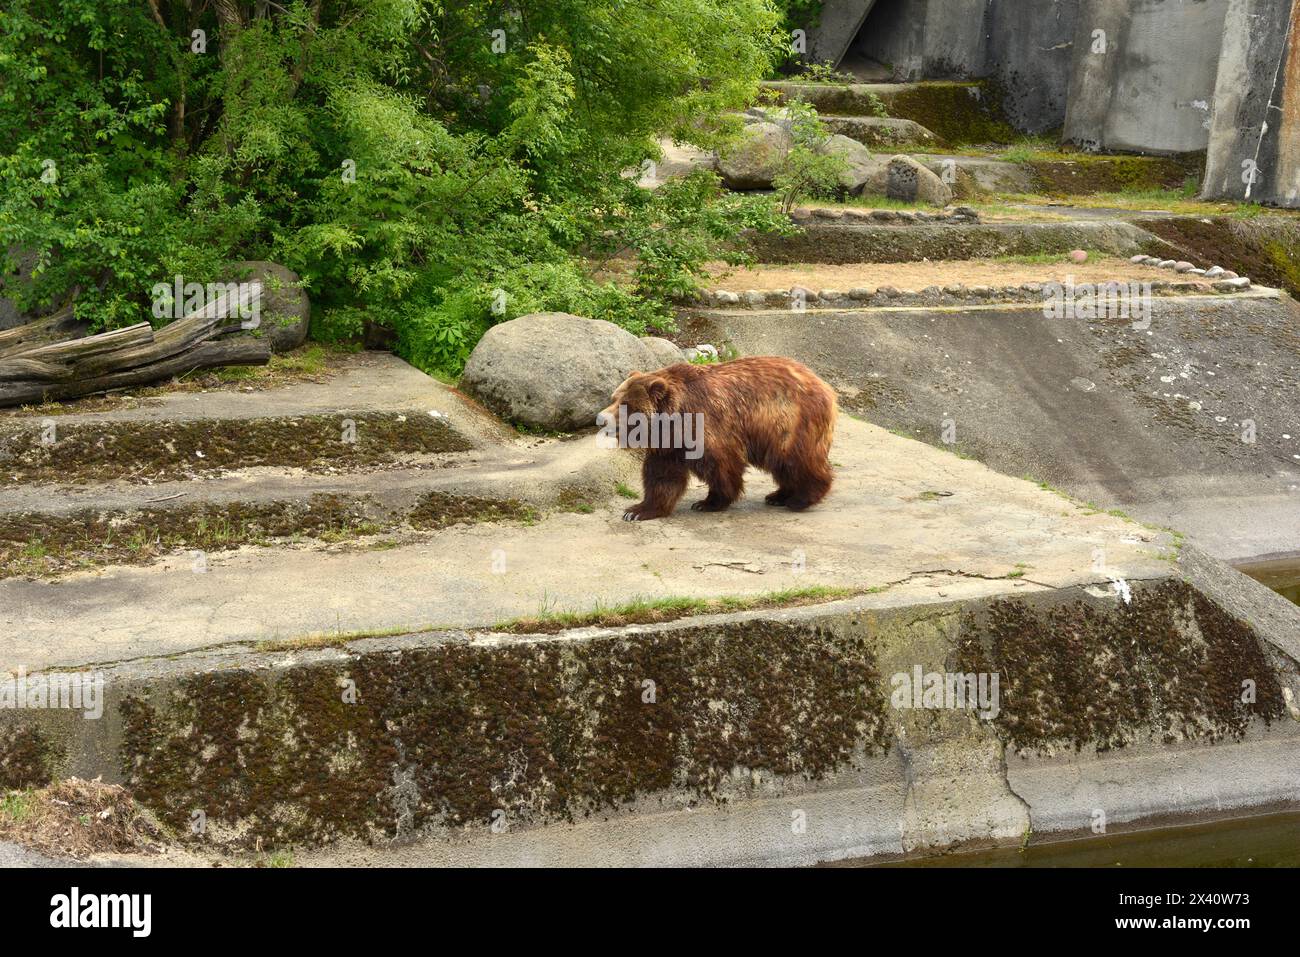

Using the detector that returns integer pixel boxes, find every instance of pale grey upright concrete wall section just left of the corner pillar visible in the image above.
[1063,0,1229,153]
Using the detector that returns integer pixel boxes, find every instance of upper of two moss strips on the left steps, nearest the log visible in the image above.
[0,412,473,484]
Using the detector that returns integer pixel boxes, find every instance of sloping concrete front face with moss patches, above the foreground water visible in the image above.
[0,558,1300,865]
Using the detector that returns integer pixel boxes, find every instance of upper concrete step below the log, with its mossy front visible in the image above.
[0,352,496,486]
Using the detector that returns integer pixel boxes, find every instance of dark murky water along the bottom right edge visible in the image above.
[841,811,1300,867]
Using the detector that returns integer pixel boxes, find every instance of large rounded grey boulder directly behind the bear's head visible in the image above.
[460,312,663,432]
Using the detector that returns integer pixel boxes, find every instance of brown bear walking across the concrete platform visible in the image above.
[597,356,836,521]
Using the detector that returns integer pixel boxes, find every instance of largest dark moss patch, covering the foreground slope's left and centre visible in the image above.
[121,623,888,845]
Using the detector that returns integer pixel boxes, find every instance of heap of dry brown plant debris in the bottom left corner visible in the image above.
[0,778,166,859]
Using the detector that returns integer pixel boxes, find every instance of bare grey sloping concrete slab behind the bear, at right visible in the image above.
[684,289,1300,563]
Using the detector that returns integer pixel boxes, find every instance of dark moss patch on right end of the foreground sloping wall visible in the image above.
[954,580,1284,752]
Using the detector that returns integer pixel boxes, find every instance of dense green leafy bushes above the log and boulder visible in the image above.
[0,0,785,373]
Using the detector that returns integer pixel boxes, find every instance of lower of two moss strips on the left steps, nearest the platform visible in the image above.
[0,492,541,579]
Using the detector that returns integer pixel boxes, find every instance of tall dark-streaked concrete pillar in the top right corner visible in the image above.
[1204,0,1300,208]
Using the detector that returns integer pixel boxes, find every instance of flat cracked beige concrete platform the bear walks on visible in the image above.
[0,416,1171,671]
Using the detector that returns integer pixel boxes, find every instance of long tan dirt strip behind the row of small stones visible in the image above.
[709,255,1187,291]
